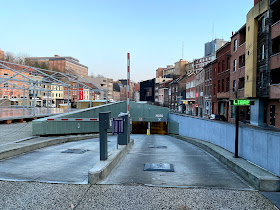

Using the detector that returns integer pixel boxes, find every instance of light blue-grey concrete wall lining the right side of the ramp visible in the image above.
[169,114,280,176]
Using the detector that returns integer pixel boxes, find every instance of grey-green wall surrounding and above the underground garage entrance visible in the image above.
[32,101,169,136]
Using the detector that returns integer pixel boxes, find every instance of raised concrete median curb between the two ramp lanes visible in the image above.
[88,139,134,184]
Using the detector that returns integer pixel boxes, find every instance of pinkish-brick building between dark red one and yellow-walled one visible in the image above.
[228,24,250,123]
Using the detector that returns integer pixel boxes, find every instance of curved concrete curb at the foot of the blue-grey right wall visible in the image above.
[170,135,280,192]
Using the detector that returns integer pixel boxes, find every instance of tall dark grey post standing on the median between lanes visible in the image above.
[99,112,111,160]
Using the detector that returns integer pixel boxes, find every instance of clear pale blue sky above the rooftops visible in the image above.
[0,0,254,82]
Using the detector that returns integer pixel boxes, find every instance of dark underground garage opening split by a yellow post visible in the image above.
[132,121,168,135]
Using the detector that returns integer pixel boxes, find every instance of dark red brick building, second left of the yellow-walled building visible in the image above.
[212,42,231,120]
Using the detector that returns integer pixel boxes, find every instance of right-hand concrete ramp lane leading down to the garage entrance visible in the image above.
[101,135,253,190]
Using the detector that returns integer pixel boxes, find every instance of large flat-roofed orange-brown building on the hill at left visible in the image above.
[27,55,88,77]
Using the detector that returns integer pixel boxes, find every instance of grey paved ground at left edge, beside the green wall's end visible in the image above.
[0,122,32,144]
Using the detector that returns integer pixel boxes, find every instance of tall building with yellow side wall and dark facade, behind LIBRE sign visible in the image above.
[244,0,270,126]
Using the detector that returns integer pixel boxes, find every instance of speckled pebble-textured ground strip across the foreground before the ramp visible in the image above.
[0,181,275,210]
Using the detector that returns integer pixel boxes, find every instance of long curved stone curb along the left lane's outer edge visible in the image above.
[0,134,99,160]
